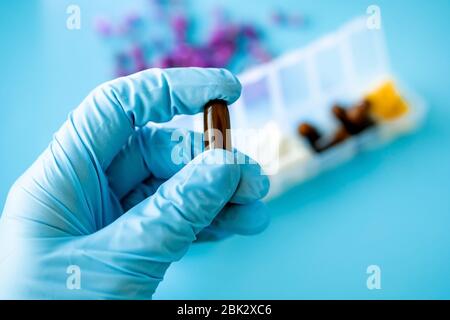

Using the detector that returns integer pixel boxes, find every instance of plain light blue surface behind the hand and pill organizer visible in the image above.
[0,0,450,299]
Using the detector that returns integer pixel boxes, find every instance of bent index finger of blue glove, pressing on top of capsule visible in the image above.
[55,68,241,170]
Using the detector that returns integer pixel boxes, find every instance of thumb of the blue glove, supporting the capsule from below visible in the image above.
[89,150,240,264]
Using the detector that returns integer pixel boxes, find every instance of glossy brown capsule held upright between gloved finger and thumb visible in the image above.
[203,100,232,151]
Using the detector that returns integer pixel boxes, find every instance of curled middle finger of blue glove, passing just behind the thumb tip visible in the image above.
[107,127,269,202]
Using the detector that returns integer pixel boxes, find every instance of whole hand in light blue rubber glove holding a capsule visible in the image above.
[0,68,269,299]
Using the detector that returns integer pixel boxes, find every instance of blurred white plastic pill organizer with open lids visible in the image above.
[164,17,426,198]
